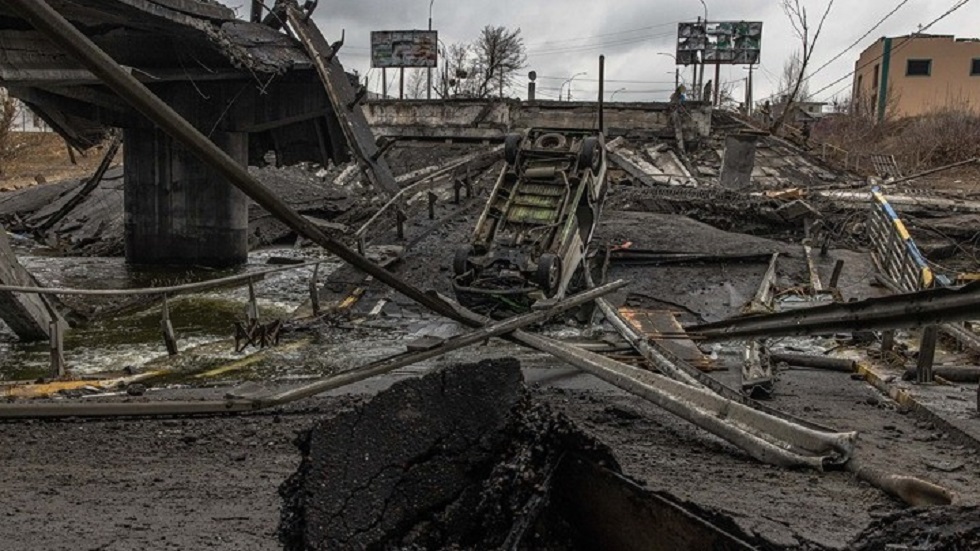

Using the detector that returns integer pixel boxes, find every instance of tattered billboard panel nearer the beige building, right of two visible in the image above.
[677,21,762,65]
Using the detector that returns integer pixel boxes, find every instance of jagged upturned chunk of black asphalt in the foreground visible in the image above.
[280,359,613,551]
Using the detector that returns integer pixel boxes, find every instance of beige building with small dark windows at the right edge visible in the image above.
[853,34,980,120]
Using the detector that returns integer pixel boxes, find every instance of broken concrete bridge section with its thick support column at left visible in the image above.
[0,0,396,266]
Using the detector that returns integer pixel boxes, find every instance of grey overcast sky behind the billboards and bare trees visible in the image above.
[223,0,980,101]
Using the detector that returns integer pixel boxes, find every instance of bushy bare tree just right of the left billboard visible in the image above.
[473,25,527,98]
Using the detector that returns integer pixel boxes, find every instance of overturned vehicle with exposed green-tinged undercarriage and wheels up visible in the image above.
[453,128,607,315]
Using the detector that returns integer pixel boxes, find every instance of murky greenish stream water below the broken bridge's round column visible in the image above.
[0,249,337,381]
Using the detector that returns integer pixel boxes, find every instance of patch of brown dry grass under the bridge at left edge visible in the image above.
[0,132,122,191]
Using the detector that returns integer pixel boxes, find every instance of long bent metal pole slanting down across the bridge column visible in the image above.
[5,0,464,324]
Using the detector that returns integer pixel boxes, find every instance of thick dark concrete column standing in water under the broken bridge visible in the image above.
[124,128,248,267]
